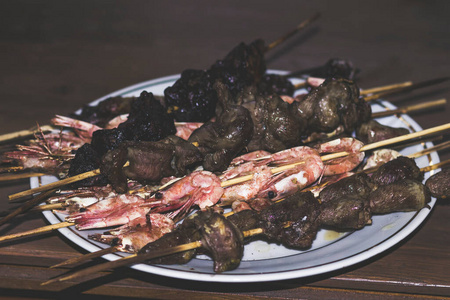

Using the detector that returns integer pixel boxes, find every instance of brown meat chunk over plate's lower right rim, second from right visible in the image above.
[369,179,431,214]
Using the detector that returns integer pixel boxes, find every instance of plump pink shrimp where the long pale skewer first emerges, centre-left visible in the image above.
[152,171,224,218]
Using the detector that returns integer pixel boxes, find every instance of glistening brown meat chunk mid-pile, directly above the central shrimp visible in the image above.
[248,95,306,152]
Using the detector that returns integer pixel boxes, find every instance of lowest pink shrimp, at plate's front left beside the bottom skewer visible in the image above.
[89,213,174,253]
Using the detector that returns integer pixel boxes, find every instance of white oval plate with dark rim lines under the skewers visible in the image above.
[35,71,439,282]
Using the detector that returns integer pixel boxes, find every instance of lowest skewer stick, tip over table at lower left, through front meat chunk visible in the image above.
[41,228,263,285]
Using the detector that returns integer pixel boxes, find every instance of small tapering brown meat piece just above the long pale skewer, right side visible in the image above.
[356,120,409,144]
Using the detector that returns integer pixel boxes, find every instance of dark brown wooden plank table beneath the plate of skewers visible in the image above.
[0,0,450,299]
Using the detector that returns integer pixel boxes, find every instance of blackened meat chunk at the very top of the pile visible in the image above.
[208,39,266,97]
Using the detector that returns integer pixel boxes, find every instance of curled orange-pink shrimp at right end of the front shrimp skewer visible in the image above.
[319,138,364,176]
